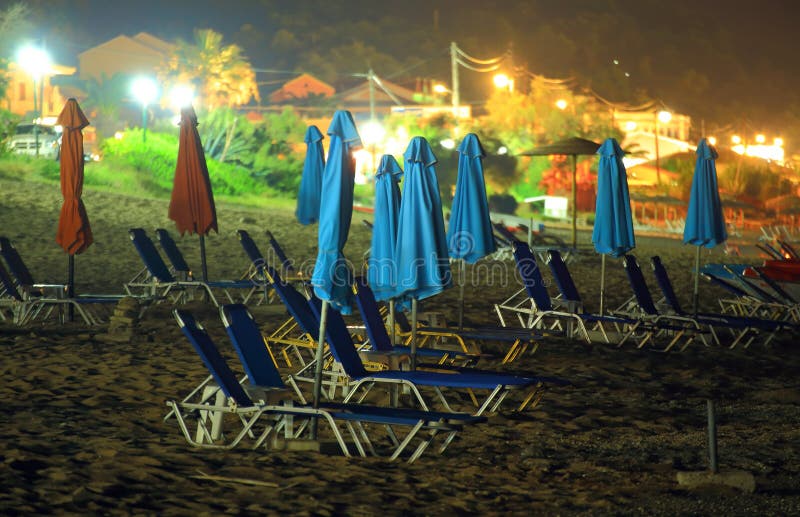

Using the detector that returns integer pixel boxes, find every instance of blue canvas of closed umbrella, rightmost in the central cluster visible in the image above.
[447,133,495,264]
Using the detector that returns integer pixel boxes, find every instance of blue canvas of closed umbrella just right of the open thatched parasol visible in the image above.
[592,138,636,257]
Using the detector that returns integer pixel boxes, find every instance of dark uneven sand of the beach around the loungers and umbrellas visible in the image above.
[0,179,800,515]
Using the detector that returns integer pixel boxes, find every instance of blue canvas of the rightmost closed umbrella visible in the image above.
[683,138,728,248]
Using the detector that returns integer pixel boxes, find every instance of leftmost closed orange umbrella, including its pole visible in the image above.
[56,99,93,320]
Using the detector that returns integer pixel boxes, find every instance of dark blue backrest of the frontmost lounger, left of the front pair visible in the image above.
[173,309,253,407]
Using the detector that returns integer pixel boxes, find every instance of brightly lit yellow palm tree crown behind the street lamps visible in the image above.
[158,29,259,109]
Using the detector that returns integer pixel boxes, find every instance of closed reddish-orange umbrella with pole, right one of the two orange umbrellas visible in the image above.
[169,106,218,282]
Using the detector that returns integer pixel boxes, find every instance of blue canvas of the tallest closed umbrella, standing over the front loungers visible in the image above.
[311,110,361,314]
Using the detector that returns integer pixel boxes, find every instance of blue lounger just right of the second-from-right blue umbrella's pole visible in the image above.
[612,255,710,352]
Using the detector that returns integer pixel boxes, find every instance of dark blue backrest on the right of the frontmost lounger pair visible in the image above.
[219,303,286,388]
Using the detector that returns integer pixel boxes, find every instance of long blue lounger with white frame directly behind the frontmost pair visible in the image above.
[309,297,569,415]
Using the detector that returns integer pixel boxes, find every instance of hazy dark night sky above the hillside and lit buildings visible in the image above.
[14,0,800,149]
